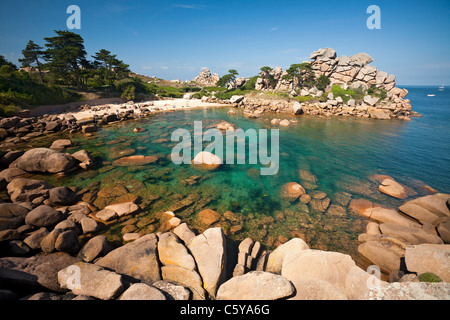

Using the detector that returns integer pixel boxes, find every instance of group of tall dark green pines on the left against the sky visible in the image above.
[19,30,130,89]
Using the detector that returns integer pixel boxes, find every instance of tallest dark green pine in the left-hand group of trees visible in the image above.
[44,30,87,89]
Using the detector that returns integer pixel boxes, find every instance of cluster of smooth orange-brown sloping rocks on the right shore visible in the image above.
[350,193,450,281]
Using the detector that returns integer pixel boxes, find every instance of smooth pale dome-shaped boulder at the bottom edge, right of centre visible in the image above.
[216,271,294,300]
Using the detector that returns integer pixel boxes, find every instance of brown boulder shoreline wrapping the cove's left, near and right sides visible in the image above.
[0,98,450,300]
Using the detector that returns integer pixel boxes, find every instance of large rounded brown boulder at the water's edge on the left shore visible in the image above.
[10,148,77,173]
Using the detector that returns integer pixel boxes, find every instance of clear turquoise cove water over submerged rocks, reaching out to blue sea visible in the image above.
[20,87,450,261]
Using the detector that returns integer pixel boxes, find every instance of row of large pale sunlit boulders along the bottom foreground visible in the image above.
[0,219,450,300]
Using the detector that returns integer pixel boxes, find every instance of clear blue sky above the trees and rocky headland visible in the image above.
[0,0,450,85]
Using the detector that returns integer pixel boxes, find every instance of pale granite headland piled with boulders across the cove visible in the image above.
[197,48,420,120]
